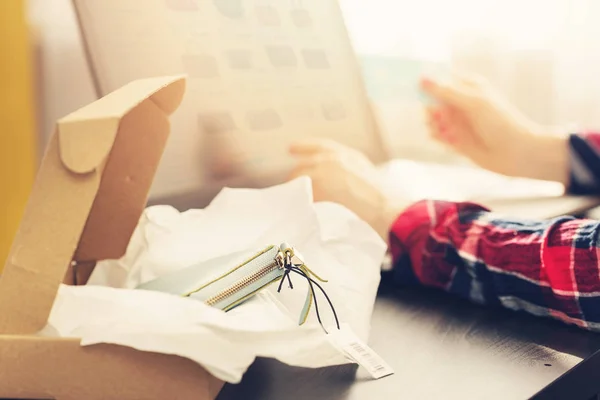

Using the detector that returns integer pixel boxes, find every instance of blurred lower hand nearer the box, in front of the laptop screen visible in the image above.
[290,139,402,241]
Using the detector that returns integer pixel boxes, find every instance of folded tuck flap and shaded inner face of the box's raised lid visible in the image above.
[58,77,185,261]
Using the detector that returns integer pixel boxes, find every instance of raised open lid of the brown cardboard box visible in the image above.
[0,77,185,334]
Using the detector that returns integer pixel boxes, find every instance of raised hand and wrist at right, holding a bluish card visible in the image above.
[421,74,569,184]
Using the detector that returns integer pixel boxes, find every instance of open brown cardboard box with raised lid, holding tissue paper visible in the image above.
[0,77,223,400]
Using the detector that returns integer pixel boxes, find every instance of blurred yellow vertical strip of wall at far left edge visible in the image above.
[0,0,36,272]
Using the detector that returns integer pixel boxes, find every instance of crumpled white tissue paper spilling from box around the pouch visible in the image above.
[46,178,386,383]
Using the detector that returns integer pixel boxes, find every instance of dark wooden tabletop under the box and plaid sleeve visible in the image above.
[218,278,600,400]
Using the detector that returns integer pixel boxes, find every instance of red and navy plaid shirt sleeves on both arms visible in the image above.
[390,134,600,331]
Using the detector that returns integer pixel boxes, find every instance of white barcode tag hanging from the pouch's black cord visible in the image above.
[328,324,394,379]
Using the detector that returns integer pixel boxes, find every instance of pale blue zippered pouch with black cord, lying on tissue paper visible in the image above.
[137,243,337,325]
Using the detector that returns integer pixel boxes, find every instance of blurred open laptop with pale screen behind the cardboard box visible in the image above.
[74,0,562,206]
